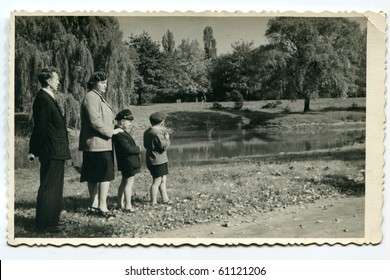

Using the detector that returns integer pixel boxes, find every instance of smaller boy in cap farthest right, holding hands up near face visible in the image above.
[144,112,172,206]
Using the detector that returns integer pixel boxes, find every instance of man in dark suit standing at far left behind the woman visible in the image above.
[28,68,70,232]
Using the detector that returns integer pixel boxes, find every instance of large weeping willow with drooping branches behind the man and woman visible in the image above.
[14,16,136,128]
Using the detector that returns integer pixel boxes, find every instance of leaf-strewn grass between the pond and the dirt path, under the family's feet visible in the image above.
[15,153,364,238]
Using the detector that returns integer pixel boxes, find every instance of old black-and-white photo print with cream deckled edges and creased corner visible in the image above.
[8,12,385,245]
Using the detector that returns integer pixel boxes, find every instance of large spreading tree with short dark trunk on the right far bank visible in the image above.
[266,17,365,112]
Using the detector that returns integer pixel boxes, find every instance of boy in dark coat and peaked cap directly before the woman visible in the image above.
[112,109,141,212]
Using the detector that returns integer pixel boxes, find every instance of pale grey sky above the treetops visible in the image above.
[118,16,365,55]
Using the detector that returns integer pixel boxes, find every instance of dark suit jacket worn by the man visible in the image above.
[29,89,71,159]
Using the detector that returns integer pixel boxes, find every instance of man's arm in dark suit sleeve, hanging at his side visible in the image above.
[28,98,51,156]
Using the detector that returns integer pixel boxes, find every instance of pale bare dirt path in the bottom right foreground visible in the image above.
[142,197,364,238]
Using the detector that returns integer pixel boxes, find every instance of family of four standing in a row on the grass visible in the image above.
[28,68,172,232]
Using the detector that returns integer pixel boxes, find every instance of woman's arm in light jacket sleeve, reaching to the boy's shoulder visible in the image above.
[84,95,114,140]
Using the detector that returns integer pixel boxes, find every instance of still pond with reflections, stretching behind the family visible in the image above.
[15,127,365,168]
